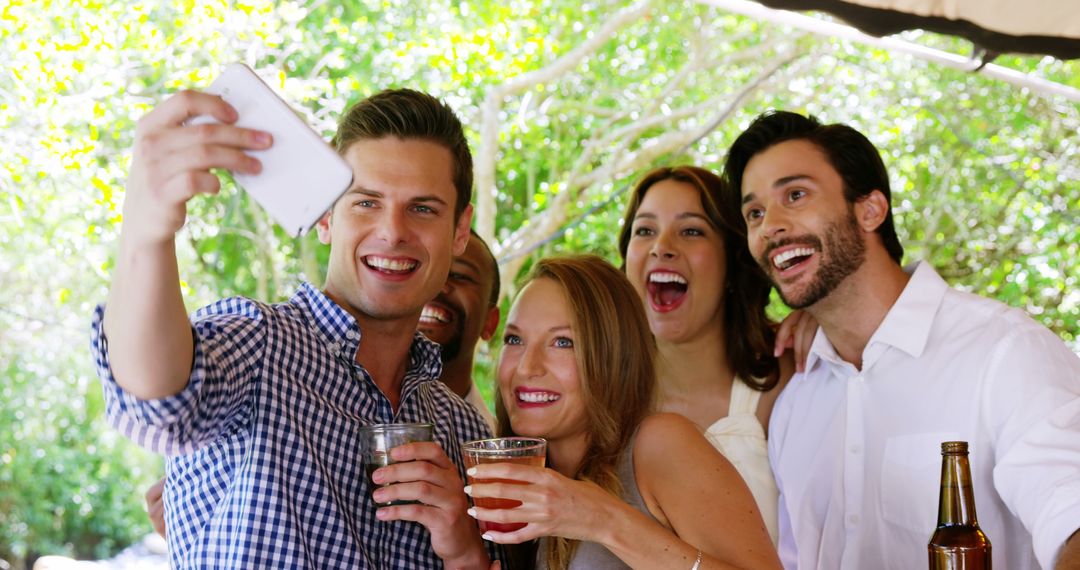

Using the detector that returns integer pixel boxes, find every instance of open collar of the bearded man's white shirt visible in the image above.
[806,261,948,371]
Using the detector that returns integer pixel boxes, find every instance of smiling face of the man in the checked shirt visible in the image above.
[319,137,472,326]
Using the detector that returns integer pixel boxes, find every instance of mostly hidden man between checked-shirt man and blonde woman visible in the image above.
[416,231,500,433]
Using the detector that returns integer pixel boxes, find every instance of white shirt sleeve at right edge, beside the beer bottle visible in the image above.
[984,318,1080,568]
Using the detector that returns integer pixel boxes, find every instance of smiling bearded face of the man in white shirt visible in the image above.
[742,139,866,309]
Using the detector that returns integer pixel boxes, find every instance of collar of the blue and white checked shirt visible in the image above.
[289,283,443,380]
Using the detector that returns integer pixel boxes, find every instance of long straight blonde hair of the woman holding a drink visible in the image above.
[496,255,657,569]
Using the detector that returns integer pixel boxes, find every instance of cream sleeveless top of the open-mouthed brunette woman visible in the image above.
[705,378,780,545]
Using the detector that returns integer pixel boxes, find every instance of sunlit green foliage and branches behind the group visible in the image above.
[0,0,1080,558]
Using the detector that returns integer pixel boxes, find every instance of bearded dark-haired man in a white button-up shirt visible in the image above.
[724,111,1080,570]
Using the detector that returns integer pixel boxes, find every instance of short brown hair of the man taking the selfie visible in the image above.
[333,89,473,216]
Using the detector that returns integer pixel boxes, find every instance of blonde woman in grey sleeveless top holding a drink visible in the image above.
[465,256,779,570]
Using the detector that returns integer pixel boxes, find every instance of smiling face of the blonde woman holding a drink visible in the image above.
[498,277,588,445]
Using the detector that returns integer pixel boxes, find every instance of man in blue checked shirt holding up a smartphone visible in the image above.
[92,90,489,569]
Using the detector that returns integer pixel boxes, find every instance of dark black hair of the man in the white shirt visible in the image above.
[721,110,904,263]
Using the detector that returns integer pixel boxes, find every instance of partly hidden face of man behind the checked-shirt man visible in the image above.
[417,238,498,362]
